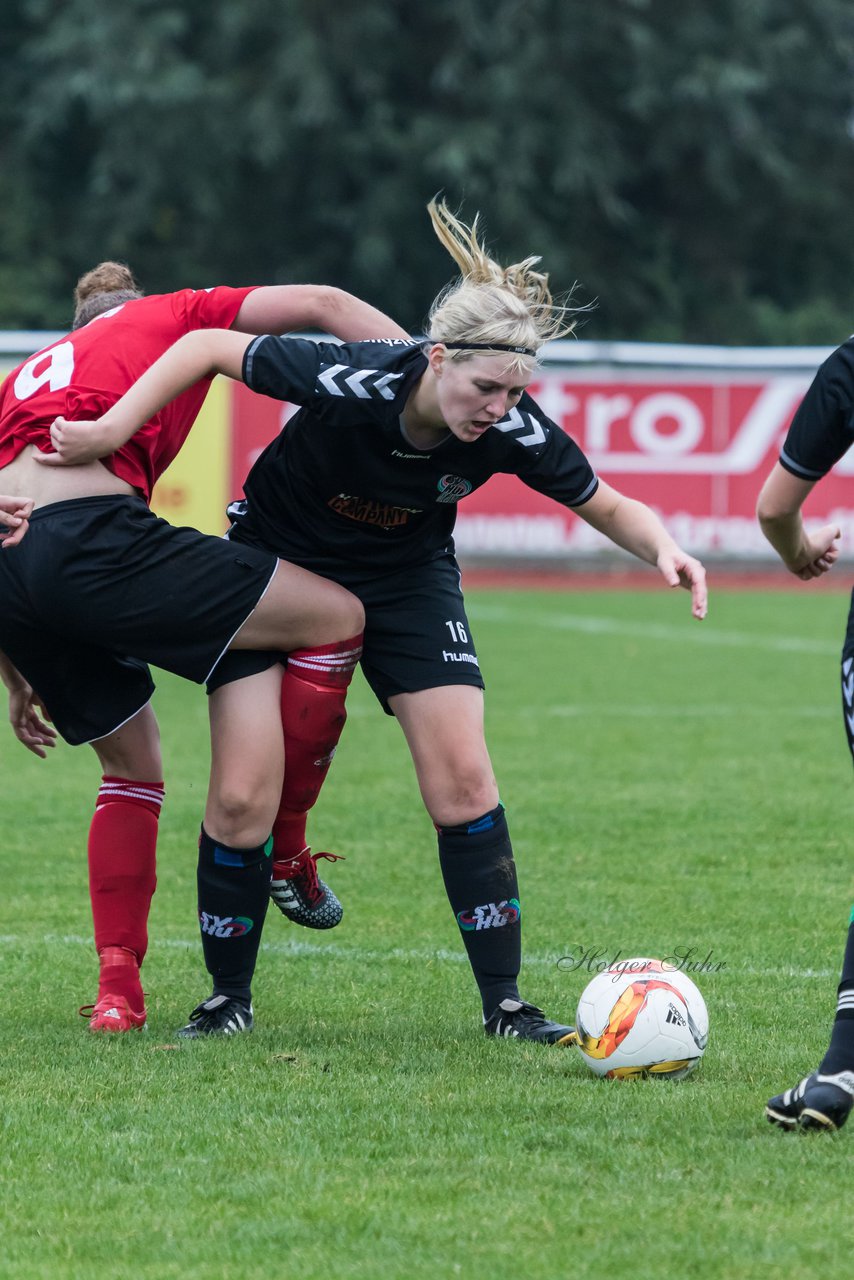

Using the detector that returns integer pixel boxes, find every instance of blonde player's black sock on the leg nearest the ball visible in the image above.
[438,805,522,1018]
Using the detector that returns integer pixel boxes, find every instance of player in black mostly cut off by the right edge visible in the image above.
[757,338,854,1130]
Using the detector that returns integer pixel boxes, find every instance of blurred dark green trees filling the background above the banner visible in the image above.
[0,0,854,343]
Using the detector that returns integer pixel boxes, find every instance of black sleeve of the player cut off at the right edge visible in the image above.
[780,338,854,480]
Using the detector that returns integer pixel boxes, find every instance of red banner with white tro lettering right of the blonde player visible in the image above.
[456,370,854,558]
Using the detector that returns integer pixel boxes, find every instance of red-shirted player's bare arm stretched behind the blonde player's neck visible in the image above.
[232,284,408,342]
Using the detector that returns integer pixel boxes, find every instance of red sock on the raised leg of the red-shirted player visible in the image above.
[273,634,362,879]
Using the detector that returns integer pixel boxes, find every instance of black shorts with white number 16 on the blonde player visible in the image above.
[207,547,484,716]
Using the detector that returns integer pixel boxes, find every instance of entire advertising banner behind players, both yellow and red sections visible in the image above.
[0,334,854,562]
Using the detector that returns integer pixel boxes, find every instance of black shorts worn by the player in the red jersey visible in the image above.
[0,495,277,745]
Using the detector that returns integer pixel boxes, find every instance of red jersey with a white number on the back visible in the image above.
[0,285,257,500]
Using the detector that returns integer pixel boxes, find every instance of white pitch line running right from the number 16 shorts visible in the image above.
[466,600,842,655]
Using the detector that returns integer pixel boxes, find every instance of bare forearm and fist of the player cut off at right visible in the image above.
[757,462,841,582]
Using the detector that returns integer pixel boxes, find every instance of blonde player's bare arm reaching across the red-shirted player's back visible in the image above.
[33,329,254,467]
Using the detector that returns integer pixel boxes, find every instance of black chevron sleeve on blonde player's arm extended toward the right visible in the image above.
[507,394,599,507]
